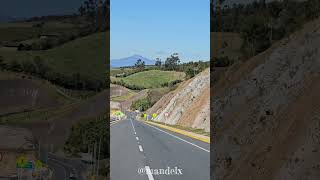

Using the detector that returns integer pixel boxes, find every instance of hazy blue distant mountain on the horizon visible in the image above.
[110,55,156,68]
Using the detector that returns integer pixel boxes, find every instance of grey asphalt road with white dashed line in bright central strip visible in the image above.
[110,112,210,180]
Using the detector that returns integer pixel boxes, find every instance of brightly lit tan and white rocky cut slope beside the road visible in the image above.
[148,69,210,131]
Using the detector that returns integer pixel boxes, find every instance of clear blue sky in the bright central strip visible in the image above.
[110,0,210,61]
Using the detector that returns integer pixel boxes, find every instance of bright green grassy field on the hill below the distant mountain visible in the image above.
[111,70,185,89]
